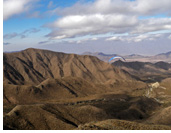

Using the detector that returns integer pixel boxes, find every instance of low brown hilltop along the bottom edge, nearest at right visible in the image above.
[77,119,171,130]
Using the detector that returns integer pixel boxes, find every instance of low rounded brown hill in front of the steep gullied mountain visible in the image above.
[4,77,111,104]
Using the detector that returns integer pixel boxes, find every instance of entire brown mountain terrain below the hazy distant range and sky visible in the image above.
[3,48,171,130]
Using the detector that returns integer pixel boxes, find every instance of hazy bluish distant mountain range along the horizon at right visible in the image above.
[83,51,171,63]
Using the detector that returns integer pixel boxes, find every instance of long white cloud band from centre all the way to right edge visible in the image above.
[47,14,171,40]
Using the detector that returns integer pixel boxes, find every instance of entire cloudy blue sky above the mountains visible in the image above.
[3,0,171,55]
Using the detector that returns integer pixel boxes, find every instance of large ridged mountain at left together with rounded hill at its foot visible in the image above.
[3,49,145,104]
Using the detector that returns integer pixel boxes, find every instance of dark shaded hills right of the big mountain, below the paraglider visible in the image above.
[112,60,171,82]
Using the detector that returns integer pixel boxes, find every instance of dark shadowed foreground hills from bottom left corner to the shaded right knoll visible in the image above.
[4,95,160,130]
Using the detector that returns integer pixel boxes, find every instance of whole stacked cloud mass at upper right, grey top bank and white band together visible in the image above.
[45,0,171,39]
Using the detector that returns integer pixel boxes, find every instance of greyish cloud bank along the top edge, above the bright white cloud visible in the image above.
[51,0,171,16]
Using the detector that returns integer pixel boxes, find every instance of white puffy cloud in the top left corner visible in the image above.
[3,0,37,20]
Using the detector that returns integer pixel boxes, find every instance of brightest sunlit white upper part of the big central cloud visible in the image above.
[54,14,137,28]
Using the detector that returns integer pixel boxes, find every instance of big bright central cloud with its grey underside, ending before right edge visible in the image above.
[45,14,137,38]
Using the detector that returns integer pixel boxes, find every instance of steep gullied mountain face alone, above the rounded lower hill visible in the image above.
[3,48,131,84]
